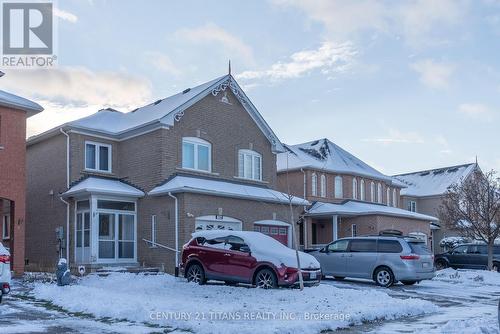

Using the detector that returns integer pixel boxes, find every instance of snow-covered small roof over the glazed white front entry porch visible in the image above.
[62,176,144,197]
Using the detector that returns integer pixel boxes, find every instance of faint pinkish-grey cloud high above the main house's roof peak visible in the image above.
[174,23,255,64]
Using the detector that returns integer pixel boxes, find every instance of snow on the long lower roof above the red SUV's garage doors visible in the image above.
[148,175,309,205]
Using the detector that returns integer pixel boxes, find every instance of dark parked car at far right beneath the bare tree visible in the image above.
[434,244,500,272]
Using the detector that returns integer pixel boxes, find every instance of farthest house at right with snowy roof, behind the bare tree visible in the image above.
[394,163,479,253]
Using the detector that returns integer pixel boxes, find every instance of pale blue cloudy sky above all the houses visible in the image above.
[0,0,500,174]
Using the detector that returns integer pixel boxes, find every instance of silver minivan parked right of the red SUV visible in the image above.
[309,236,434,287]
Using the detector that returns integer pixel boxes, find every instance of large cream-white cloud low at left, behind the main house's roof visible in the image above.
[2,67,152,135]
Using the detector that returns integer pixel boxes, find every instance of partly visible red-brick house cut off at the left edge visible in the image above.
[0,90,43,275]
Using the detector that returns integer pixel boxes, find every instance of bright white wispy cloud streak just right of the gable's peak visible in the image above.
[236,41,357,81]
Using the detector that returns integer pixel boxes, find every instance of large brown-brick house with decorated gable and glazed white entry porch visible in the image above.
[26,74,307,273]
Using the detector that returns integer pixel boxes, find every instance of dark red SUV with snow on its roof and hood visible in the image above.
[180,230,321,289]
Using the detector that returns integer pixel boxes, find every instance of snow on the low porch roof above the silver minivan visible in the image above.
[307,201,438,221]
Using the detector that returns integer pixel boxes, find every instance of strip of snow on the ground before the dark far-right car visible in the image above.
[433,268,500,286]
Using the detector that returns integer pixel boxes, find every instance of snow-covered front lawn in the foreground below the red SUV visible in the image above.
[32,273,437,333]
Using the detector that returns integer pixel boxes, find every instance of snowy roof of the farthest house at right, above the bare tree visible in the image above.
[394,163,477,197]
